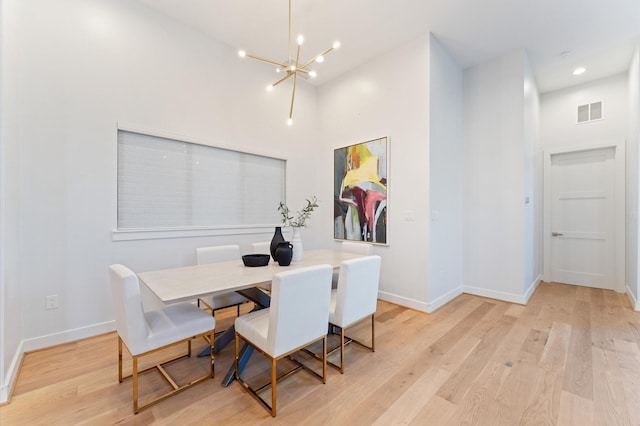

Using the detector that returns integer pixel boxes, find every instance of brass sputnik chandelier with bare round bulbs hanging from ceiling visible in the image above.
[238,0,340,126]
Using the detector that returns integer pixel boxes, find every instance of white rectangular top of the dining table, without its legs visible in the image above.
[138,250,362,303]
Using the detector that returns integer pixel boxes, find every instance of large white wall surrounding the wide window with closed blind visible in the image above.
[0,0,320,396]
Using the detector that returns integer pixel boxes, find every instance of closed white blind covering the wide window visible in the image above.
[118,130,286,230]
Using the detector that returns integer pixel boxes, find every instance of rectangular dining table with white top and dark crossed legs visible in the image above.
[138,250,362,386]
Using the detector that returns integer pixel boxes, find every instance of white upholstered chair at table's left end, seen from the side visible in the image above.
[109,265,216,413]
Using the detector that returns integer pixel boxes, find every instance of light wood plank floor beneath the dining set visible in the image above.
[0,283,640,426]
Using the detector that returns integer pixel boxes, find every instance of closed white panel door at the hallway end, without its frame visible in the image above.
[550,148,615,289]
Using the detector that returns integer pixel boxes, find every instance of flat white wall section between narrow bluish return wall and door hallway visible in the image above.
[463,50,531,303]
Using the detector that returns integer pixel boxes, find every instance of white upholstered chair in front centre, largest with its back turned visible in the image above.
[235,265,332,417]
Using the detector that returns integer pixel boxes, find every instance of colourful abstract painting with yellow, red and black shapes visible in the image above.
[333,137,388,244]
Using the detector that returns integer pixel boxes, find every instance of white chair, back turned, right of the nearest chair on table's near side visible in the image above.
[329,256,381,373]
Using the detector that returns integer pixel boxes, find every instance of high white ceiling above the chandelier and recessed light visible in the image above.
[138,0,640,92]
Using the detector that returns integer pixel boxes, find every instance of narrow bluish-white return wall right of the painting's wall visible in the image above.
[428,35,464,312]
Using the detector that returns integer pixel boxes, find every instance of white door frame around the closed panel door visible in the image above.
[542,140,626,293]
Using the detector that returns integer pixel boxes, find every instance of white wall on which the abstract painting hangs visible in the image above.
[317,35,430,311]
